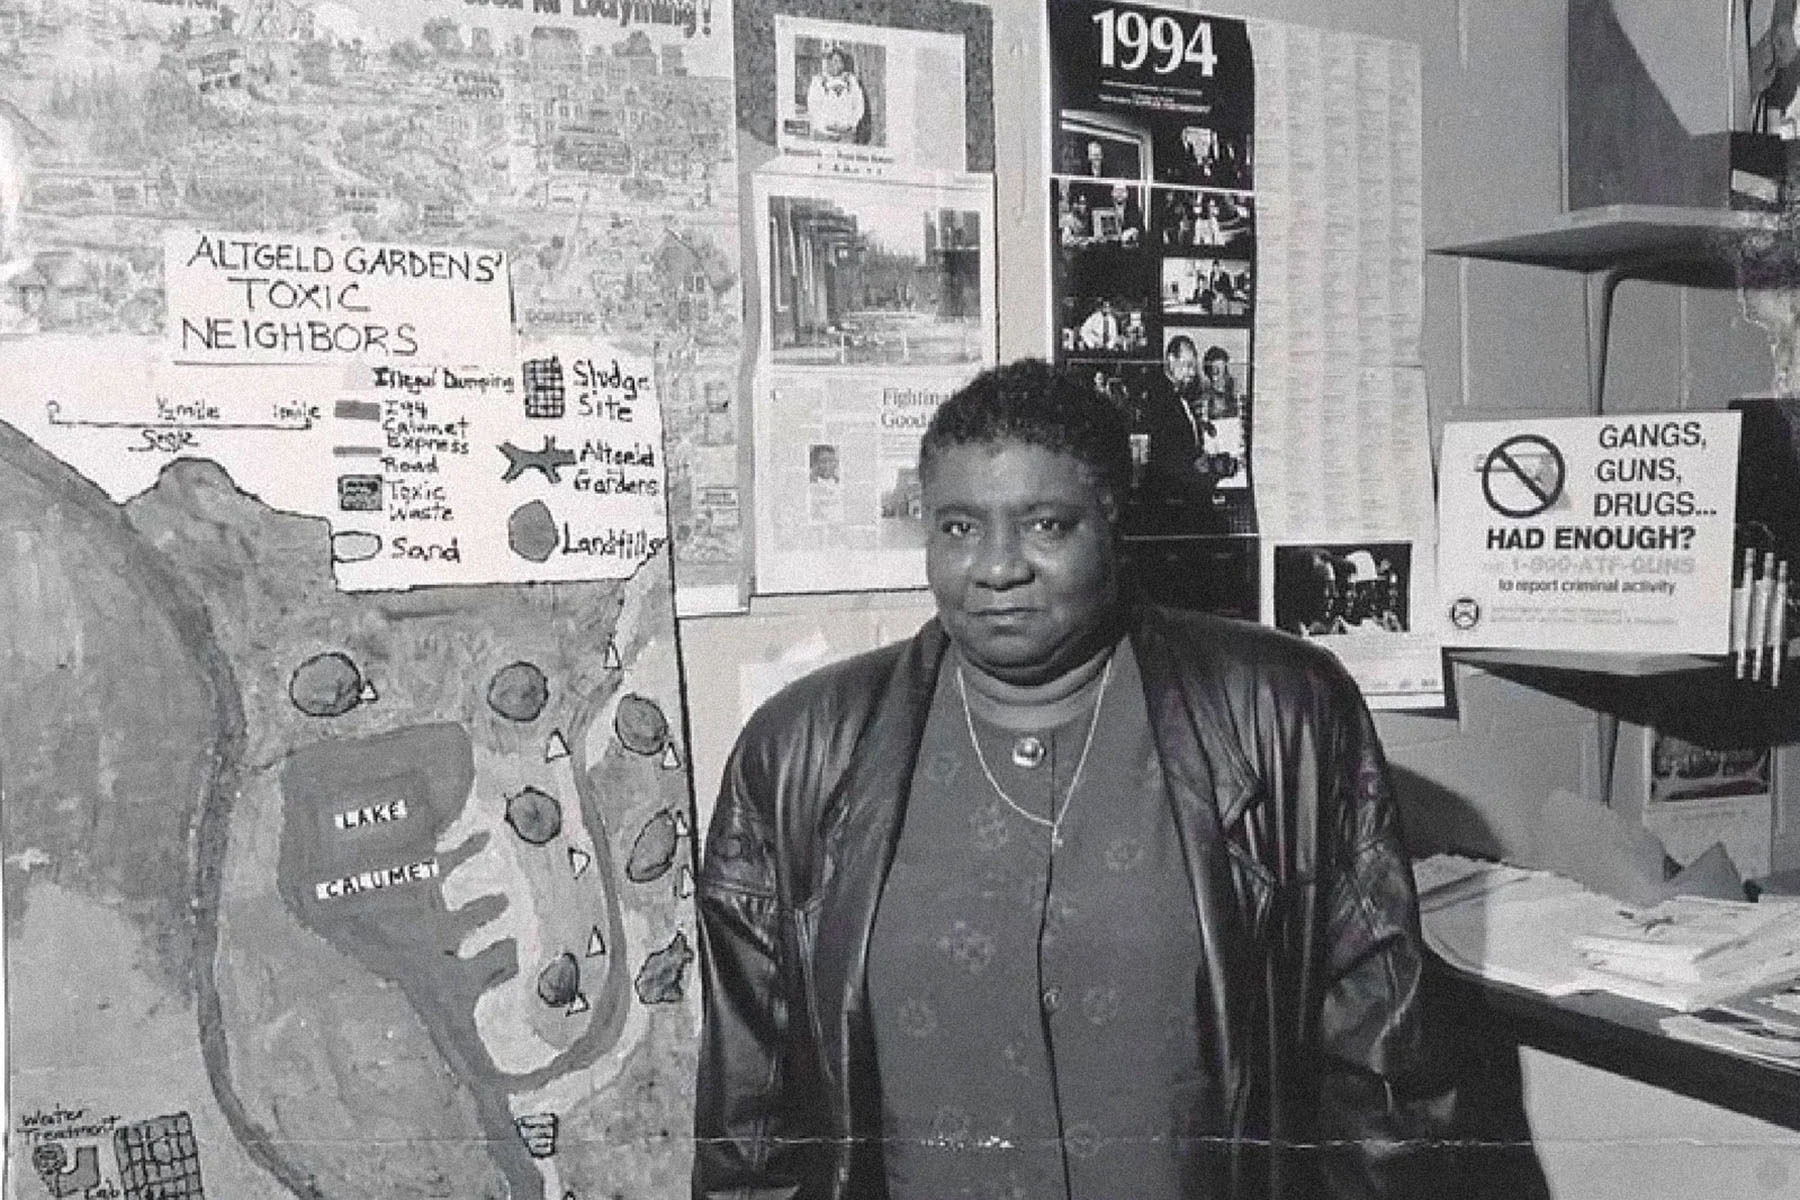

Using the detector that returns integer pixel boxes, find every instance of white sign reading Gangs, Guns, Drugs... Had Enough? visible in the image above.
[1438,412,1739,655]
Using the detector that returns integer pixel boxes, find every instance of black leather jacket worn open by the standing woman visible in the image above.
[693,608,1451,1200]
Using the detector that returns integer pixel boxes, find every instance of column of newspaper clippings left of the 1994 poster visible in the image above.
[740,9,997,594]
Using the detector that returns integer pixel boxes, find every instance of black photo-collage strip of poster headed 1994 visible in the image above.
[1048,0,1258,619]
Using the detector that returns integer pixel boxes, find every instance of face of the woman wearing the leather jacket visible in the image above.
[923,441,1118,684]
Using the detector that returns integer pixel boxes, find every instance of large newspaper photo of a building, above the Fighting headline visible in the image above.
[765,182,988,367]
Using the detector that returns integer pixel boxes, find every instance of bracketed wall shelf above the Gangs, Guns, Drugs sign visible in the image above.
[1431,205,1775,282]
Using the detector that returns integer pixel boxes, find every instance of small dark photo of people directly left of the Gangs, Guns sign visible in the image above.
[1274,542,1413,637]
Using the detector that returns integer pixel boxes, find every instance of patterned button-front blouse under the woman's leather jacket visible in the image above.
[868,644,1210,1200]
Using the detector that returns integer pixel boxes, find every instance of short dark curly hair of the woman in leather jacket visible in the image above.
[918,358,1130,513]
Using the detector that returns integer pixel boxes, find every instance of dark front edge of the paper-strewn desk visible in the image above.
[1426,955,1800,1130]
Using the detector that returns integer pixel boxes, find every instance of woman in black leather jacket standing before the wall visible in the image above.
[695,362,1444,1200]
